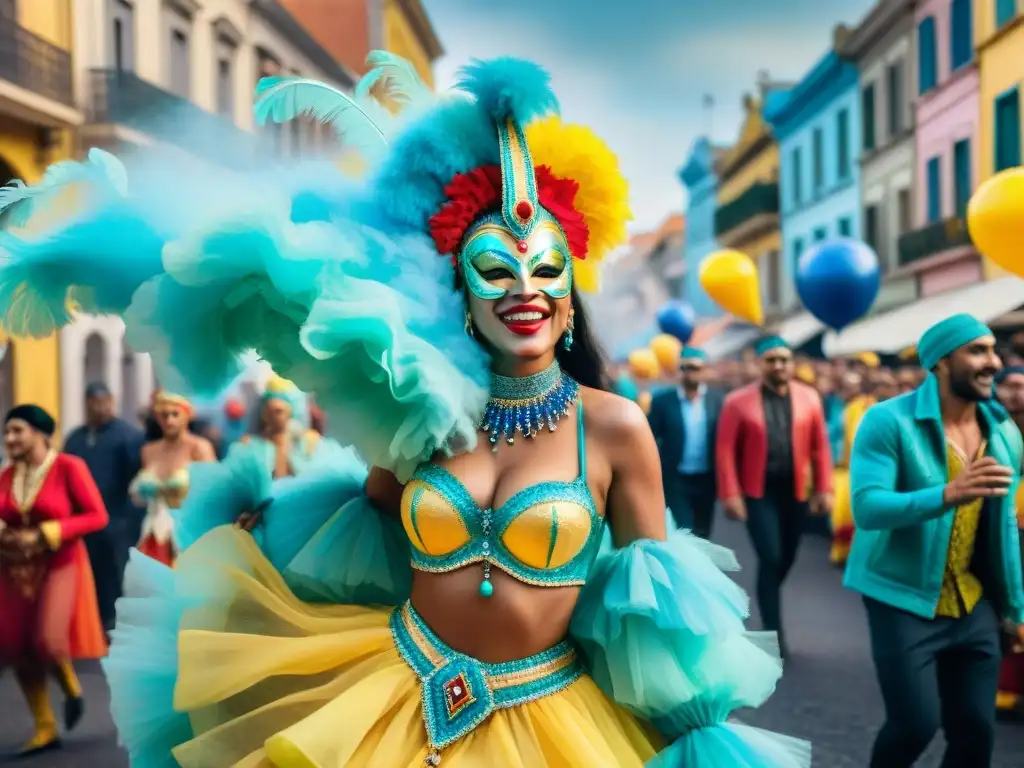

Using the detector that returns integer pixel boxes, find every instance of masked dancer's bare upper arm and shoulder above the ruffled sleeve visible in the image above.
[587,396,666,547]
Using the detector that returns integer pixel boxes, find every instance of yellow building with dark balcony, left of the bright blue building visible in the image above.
[715,89,782,315]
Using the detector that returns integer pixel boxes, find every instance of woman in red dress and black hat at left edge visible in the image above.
[0,406,106,755]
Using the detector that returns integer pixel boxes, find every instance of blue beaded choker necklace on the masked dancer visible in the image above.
[480,360,580,451]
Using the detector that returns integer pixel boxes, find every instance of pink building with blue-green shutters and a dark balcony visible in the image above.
[899,0,982,296]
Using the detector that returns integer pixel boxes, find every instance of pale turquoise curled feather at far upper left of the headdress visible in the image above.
[255,77,387,155]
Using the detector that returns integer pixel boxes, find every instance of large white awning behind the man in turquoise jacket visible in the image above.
[822,278,1024,357]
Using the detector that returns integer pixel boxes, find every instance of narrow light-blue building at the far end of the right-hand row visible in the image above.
[679,136,723,317]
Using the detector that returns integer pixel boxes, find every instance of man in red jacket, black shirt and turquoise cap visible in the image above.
[715,336,831,655]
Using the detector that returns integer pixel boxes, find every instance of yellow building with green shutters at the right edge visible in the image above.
[974,0,1024,280]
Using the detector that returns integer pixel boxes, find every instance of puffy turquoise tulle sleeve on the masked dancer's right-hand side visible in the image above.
[570,530,811,768]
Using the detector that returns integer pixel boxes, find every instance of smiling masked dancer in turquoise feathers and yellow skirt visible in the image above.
[0,52,810,768]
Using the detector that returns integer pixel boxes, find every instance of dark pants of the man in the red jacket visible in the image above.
[746,478,808,642]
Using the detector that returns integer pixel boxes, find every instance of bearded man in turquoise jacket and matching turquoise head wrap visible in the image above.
[845,314,1024,768]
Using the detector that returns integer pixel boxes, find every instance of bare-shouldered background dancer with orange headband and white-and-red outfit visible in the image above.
[130,390,217,565]
